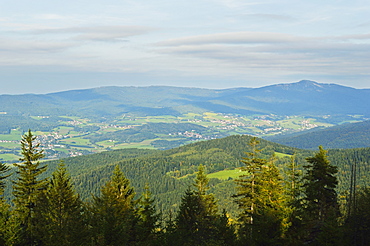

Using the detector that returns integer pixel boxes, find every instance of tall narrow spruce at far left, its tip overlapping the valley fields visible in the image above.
[13,130,47,245]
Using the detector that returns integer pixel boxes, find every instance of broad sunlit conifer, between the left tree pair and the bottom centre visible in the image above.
[91,165,137,246]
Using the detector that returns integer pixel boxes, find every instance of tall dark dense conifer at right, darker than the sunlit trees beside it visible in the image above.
[302,146,340,245]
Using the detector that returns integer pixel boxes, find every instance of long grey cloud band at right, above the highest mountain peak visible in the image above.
[156,32,370,77]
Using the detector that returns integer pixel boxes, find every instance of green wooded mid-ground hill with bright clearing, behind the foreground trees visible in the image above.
[35,135,370,216]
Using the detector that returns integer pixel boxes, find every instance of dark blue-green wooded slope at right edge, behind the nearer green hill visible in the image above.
[267,118,370,149]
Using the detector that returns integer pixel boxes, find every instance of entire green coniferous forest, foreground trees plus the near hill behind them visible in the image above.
[0,131,370,246]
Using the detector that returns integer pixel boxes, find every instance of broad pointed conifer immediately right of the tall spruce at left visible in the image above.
[35,162,88,246]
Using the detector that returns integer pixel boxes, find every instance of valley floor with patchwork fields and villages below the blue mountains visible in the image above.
[0,112,365,162]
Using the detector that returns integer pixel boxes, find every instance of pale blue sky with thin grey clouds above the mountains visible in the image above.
[0,0,370,94]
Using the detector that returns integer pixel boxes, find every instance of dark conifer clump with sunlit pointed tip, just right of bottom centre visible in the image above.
[174,166,234,245]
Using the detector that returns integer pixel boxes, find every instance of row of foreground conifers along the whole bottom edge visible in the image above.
[0,131,370,246]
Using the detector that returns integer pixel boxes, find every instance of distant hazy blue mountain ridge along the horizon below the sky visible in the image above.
[0,80,370,117]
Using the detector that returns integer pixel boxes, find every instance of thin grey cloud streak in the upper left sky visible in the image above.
[32,26,153,42]
